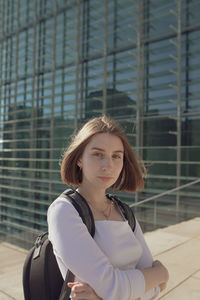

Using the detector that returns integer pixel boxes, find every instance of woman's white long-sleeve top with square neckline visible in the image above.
[47,196,159,300]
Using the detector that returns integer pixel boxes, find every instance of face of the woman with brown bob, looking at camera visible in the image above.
[78,133,124,189]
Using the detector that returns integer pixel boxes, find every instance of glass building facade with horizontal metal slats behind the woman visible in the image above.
[0,0,200,248]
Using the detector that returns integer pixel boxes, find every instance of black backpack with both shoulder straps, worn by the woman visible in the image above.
[23,189,136,300]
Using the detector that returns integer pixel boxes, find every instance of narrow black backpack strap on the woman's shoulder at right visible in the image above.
[106,194,136,232]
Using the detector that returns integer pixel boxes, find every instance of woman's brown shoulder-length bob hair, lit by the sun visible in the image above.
[61,116,145,192]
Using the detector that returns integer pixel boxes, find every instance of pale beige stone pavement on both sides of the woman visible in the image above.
[0,217,200,300]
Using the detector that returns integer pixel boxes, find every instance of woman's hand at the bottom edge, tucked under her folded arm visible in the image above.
[67,282,102,300]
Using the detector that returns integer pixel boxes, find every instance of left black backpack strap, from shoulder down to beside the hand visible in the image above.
[59,189,95,300]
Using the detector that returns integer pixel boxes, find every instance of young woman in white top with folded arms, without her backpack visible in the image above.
[48,116,168,300]
